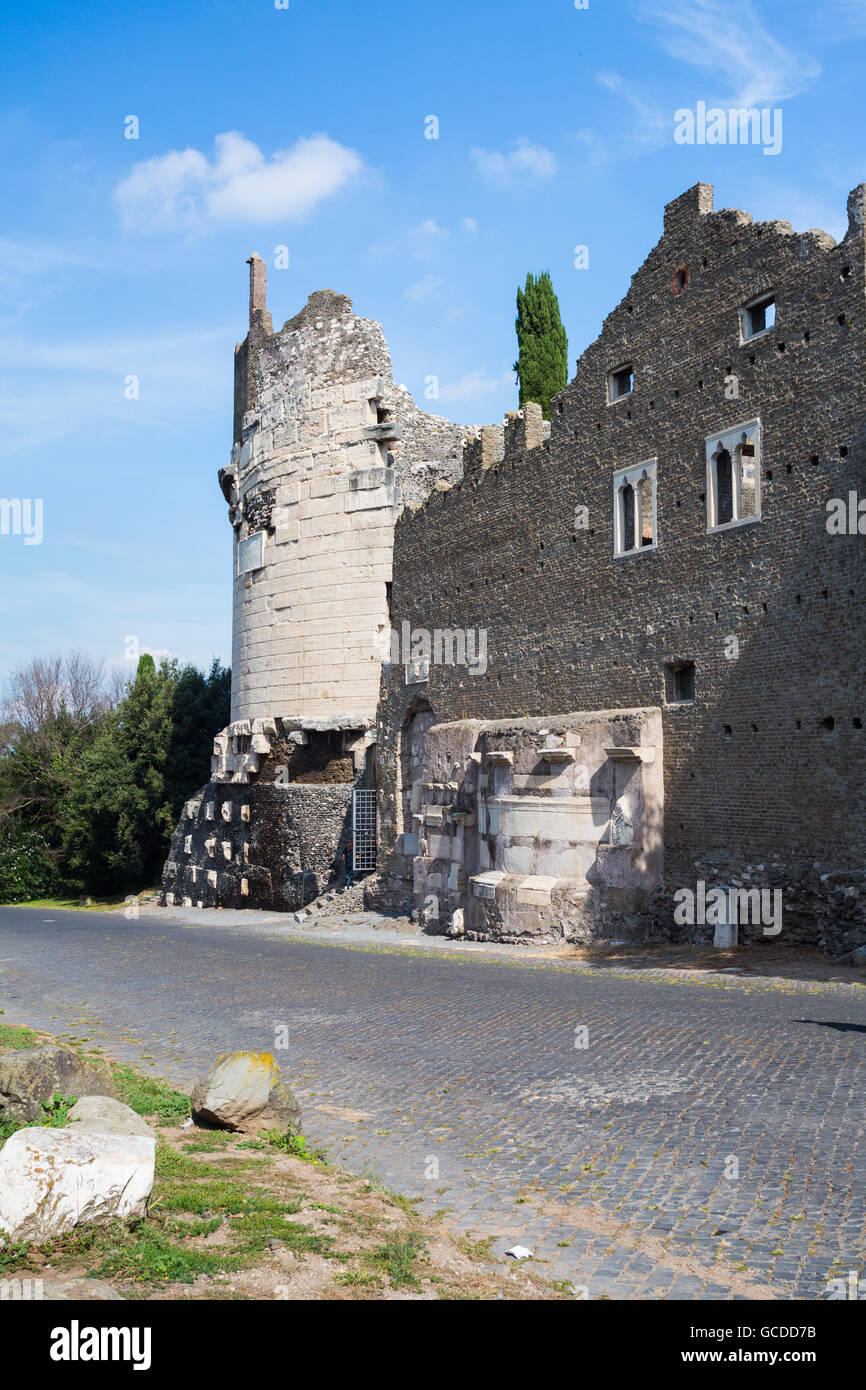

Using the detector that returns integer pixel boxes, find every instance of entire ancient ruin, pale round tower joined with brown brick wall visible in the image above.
[164,183,866,951]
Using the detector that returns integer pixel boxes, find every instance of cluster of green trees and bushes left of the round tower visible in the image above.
[0,652,231,902]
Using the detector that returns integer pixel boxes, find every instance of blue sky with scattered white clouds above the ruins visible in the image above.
[0,0,866,677]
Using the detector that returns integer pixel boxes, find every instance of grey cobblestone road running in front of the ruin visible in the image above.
[0,908,866,1298]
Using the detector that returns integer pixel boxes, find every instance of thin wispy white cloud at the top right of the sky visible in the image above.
[635,0,822,106]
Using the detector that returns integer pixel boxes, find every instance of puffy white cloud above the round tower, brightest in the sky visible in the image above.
[114,131,364,234]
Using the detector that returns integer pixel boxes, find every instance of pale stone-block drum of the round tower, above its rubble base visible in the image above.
[229,257,402,727]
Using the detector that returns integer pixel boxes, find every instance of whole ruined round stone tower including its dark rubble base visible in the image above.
[164,256,475,908]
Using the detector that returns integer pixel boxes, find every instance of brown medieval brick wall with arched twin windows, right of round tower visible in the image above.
[378,185,866,941]
